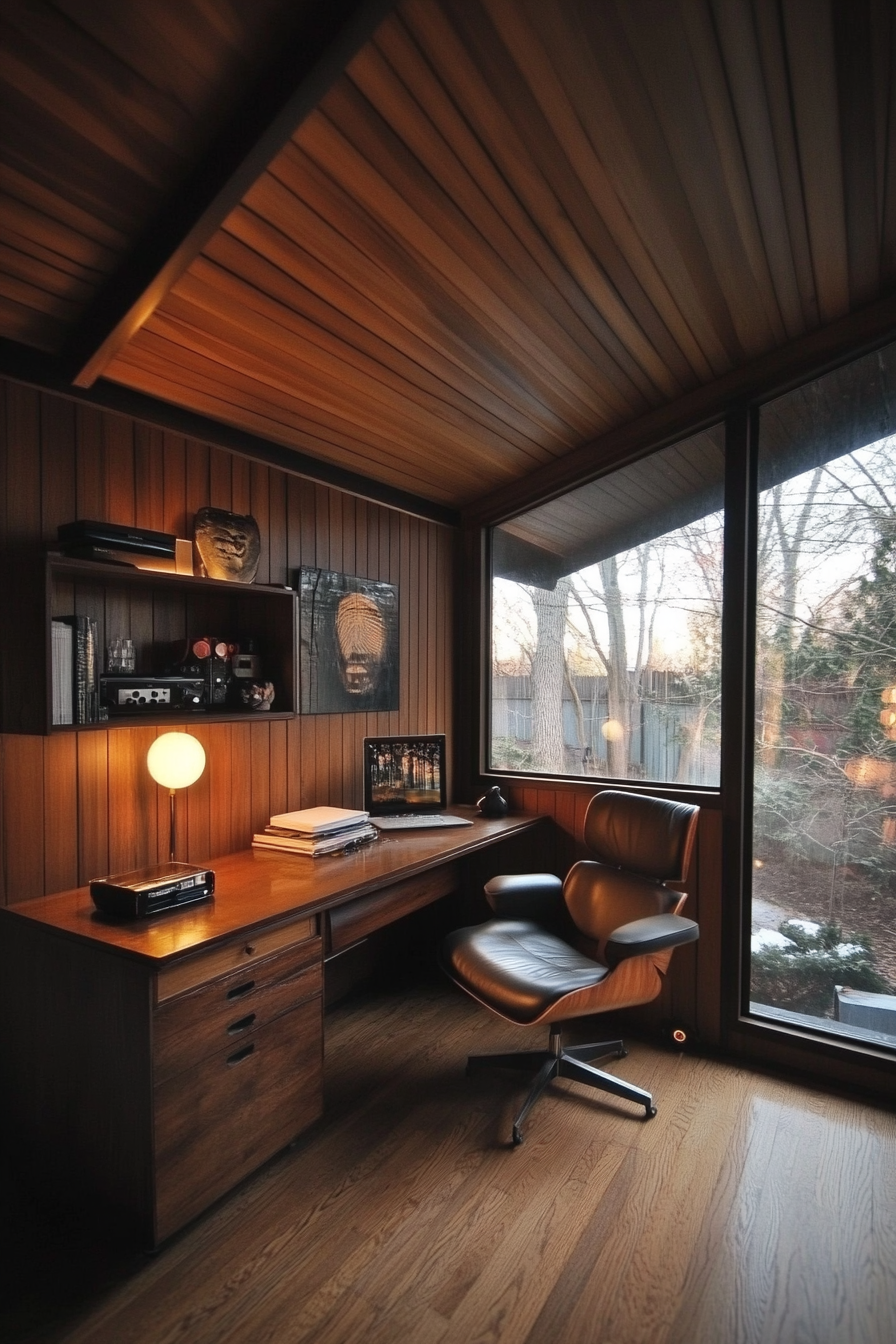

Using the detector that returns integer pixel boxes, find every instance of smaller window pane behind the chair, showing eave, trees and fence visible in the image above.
[489,426,724,788]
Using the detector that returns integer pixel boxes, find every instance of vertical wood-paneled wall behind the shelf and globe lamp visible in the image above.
[0,383,455,905]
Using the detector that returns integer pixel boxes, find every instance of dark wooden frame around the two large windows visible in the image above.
[467,314,896,1095]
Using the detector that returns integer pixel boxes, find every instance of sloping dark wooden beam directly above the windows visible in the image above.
[462,294,896,527]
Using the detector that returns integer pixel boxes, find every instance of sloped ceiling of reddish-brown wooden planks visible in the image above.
[0,0,896,534]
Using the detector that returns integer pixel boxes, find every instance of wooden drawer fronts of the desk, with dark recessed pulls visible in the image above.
[152,919,324,1243]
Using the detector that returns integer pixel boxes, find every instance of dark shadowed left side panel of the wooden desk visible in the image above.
[0,919,152,1231]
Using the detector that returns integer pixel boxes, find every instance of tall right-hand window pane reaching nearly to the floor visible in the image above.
[750,338,896,1047]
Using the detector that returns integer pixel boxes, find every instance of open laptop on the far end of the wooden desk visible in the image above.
[363,732,473,831]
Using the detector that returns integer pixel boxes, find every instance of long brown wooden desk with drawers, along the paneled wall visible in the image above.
[0,808,540,1246]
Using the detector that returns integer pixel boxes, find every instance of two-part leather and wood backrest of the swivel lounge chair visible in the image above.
[563,789,700,958]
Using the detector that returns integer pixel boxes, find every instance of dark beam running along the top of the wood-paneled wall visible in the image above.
[0,337,451,527]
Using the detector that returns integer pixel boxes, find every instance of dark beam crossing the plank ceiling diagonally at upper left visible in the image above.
[60,0,395,387]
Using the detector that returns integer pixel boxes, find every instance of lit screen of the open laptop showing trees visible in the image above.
[364,732,447,817]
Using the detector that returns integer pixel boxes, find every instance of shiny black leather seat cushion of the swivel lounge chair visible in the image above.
[442,919,610,1024]
